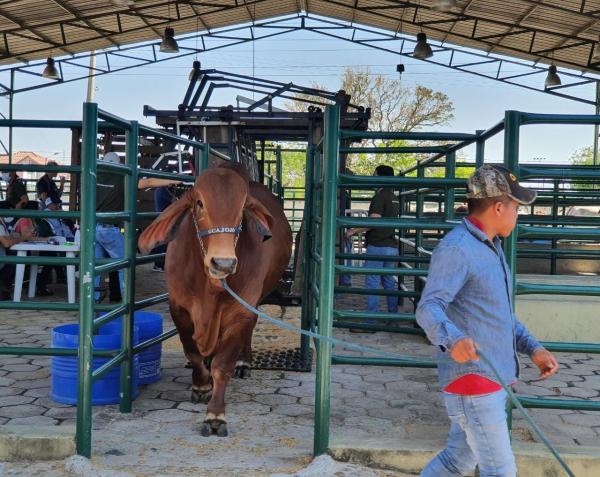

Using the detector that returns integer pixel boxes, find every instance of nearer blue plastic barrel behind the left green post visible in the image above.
[50,324,139,404]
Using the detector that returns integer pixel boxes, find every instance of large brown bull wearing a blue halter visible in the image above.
[139,165,292,436]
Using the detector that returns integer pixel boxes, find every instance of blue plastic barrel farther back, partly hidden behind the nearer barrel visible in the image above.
[104,311,163,384]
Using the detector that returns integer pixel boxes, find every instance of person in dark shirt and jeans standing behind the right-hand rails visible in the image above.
[346,165,400,331]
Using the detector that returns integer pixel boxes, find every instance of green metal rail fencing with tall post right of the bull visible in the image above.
[312,106,600,455]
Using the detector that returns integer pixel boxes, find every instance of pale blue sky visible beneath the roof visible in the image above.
[0,26,594,164]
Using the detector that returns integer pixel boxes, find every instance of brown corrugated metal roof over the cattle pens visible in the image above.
[0,0,600,72]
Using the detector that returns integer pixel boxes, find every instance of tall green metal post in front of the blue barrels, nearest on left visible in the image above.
[76,103,98,457]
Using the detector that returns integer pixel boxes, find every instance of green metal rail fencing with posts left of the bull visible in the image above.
[0,103,229,457]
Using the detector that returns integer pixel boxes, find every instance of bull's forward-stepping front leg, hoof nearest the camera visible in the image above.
[200,316,256,437]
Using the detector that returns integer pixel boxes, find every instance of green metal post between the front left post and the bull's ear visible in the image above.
[119,121,139,412]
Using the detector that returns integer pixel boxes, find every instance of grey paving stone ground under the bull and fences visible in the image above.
[0,265,600,477]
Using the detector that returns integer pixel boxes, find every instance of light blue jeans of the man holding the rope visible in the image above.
[420,390,517,477]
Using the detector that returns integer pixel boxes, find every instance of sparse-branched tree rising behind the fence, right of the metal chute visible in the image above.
[288,68,454,175]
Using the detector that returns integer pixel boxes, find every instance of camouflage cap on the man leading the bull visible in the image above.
[467,164,537,205]
